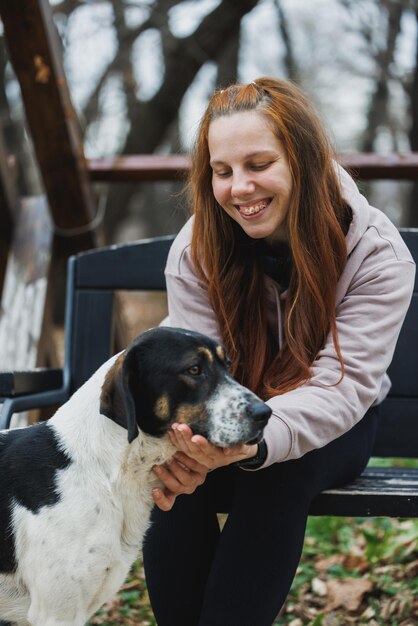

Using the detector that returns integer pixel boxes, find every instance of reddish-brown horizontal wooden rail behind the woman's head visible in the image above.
[87,152,418,183]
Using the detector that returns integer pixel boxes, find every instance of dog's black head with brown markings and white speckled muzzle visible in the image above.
[100,327,271,447]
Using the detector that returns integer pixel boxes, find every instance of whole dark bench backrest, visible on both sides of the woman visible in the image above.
[65,229,418,457]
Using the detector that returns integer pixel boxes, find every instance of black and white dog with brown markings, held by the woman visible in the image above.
[0,328,271,626]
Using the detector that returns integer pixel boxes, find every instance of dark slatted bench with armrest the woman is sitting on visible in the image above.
[0,230,418,517]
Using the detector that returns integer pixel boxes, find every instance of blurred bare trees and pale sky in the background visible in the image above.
[0,0,418,242]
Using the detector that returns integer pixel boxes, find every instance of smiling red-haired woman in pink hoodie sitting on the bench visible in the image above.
[144,78,415,626]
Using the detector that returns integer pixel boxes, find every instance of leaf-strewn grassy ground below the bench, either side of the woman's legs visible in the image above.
[89,517,418,626]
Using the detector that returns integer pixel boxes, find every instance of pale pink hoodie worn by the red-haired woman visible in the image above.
[163,168,415,467]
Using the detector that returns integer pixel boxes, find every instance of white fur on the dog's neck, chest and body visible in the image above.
[0,352,174,626]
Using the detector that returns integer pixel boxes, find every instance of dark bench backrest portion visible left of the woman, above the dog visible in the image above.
[65,235,174,392]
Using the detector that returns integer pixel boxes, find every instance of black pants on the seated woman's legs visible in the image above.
[143,409,377,626]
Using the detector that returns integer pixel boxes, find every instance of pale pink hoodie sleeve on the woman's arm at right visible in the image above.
[263,252,415,467]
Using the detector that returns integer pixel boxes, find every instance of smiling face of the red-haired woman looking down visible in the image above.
[208,111,293,243]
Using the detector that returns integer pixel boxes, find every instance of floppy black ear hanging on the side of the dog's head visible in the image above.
[100,352,138,443]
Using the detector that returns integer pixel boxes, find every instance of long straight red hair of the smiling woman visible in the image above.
[189,78,349,399]
